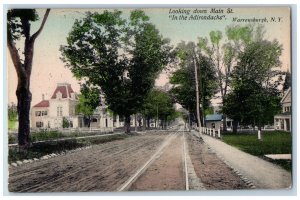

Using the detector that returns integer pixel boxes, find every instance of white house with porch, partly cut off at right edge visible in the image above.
[274,88,292,131]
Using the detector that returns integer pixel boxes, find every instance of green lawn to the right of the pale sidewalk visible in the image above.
[222,131,292,171]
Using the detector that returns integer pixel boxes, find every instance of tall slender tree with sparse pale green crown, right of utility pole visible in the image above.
[198,25,263,130]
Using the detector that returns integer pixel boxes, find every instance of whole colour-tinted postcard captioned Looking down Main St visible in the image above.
[7,6,293,195]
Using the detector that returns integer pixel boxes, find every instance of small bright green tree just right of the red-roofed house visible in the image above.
[75,84,100,127]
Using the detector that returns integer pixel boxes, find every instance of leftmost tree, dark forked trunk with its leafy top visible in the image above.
[7,9,50,147]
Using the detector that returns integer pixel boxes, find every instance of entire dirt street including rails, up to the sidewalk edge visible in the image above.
[9,127,250,192]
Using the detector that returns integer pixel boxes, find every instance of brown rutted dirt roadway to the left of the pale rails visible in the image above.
[9,133,168,192]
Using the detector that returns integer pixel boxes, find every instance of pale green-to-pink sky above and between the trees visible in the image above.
[7,7,291,106]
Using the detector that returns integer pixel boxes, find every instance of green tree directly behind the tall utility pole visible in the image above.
[170,42,217,127]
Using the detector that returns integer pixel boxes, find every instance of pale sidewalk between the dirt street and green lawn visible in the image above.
[194,132,292,189]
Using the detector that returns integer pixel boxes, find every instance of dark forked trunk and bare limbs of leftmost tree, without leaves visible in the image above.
[7,9,50,148]
